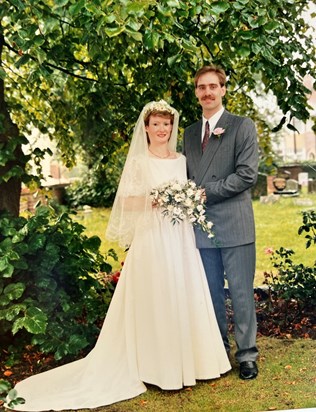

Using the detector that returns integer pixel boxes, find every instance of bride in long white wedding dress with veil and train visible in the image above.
[9,101,230,411]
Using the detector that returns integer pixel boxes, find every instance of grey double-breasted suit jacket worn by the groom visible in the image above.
[183,110,258,248]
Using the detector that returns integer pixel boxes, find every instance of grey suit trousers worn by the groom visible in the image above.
[200,243,258,362]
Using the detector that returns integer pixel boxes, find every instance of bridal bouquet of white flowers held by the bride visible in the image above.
[150,180,214,238]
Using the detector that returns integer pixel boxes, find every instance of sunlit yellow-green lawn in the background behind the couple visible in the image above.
[77,194,316,286]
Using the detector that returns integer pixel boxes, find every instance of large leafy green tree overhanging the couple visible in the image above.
[0,0,315,214]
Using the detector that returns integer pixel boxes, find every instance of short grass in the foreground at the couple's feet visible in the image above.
[62,338,316,412]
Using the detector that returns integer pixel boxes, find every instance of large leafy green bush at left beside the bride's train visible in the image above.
[0,206,115,359]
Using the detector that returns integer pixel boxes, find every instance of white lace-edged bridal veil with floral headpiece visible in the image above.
[106,100,179,248]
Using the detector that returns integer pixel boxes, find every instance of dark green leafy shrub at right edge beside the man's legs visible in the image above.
[265,210,316,308]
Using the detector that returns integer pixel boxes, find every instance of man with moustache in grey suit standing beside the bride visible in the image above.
[183,66,258,380]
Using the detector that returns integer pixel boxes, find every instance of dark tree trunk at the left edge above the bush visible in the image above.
[0,29,25,216]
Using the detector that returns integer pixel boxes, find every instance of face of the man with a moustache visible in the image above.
[195,72,226,118]
